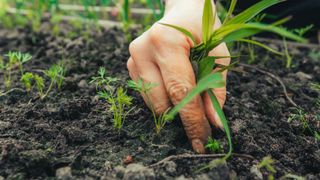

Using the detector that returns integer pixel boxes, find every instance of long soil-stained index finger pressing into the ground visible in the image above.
[151,29,211,153]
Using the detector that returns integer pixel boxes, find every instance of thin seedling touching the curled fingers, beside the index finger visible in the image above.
[127,78,170,135]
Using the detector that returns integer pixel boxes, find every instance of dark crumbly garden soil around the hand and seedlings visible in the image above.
[0,21,320,179]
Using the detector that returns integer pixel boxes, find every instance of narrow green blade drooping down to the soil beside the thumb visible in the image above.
[207,90,233,159]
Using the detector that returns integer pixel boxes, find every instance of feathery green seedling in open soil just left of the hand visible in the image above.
[90,67,134,130]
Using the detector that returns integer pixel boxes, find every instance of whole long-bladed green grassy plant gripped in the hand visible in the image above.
[163,0,305,160]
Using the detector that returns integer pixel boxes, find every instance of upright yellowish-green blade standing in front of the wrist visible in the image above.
[202,0,215,44]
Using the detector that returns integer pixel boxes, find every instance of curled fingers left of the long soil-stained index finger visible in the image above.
[127,38,171,115]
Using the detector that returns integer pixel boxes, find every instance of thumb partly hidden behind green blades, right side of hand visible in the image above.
[202,44,230,130]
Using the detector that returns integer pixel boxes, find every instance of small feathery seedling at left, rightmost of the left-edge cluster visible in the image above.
[39,64,65,99]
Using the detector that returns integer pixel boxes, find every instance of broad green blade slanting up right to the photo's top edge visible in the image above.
[225,0,283,25]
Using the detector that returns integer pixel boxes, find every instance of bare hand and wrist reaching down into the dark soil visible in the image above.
[127,0,230,153]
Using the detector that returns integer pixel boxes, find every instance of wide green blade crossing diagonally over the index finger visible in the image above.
[166,73,225,120]
